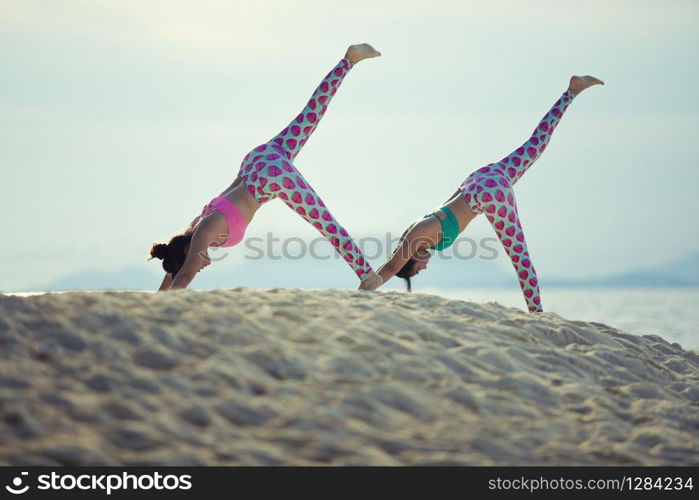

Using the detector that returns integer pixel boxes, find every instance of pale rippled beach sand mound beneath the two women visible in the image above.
[0,289,699,465]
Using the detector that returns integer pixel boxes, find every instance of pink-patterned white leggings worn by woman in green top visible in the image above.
[459,91,575,312]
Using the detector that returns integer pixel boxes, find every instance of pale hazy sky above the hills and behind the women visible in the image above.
[0,0,699,290]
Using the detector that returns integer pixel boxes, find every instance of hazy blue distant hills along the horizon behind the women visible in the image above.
[14,252,699,292]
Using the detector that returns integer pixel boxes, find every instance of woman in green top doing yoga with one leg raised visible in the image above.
[370,76,604,312]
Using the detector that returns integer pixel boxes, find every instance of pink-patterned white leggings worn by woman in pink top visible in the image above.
[238,59,372,280]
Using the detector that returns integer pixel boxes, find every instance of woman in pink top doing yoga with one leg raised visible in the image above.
[150,43,381,290]
